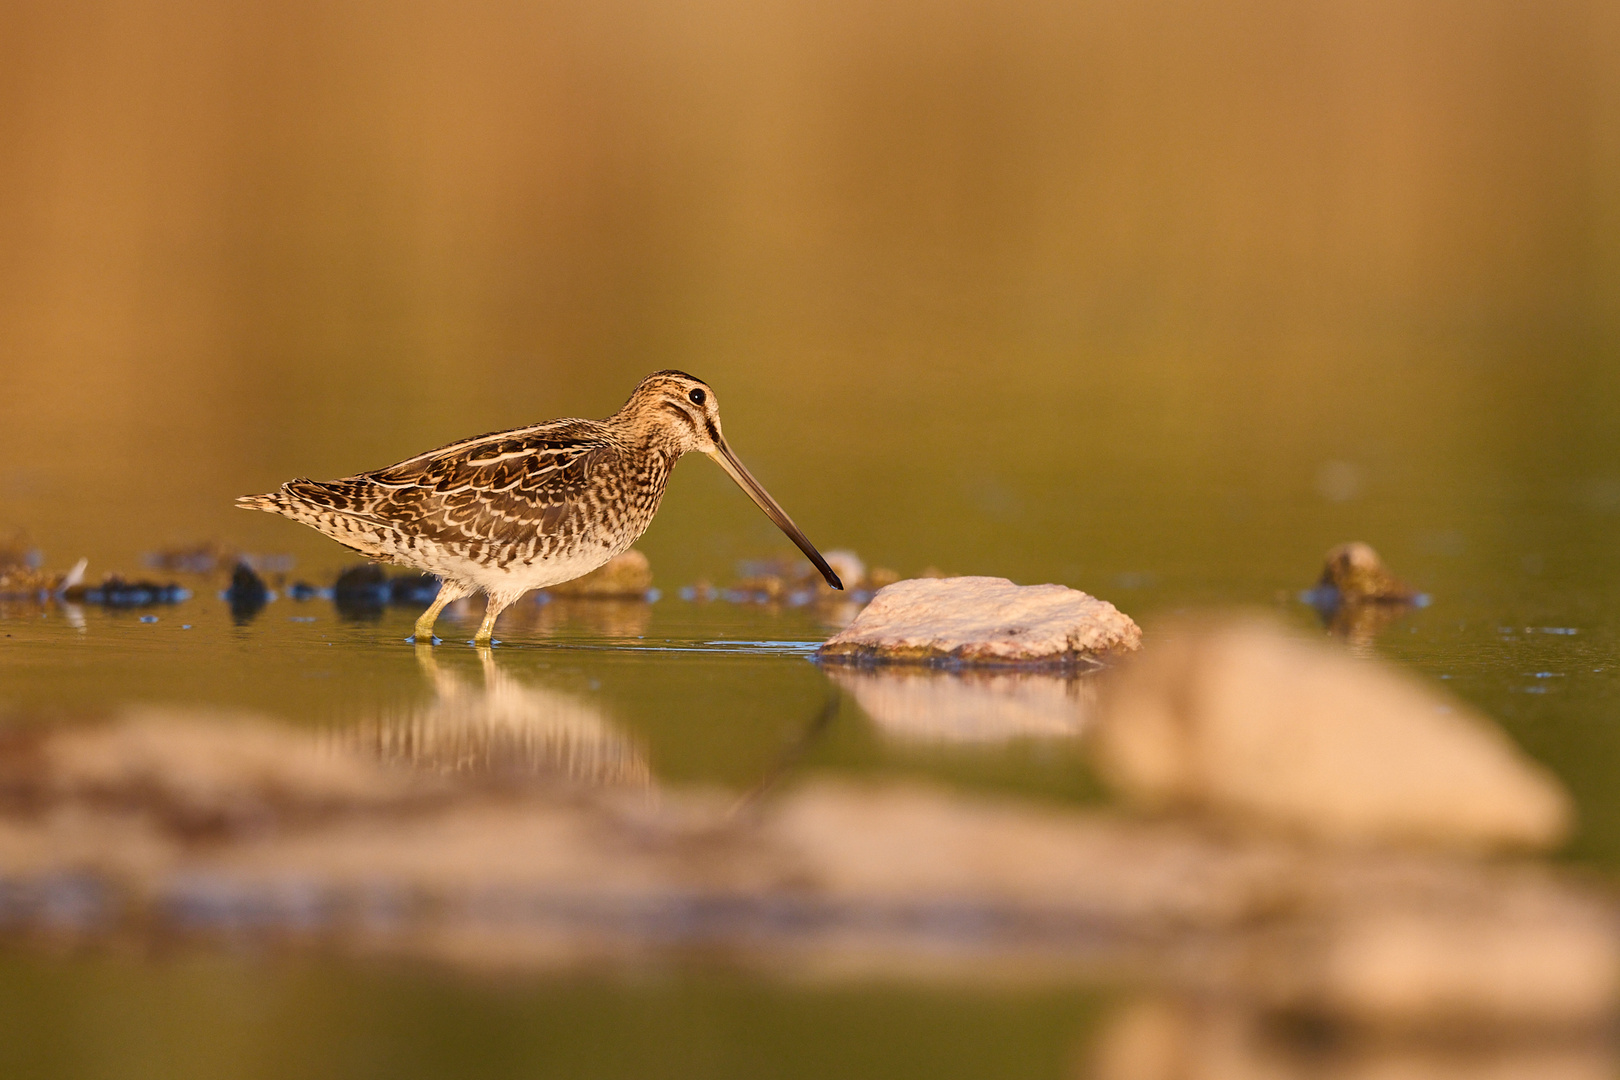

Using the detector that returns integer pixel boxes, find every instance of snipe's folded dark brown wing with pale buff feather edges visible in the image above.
[288,421,617,544]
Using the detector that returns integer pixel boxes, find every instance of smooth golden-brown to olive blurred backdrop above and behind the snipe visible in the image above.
[0,0,1620,593]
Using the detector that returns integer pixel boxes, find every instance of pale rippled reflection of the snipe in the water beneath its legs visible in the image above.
[335,646,653,787]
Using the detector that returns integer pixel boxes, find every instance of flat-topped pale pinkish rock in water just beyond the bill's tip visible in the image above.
[816,578,1142,665]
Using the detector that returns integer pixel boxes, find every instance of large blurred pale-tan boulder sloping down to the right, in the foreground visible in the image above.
[1094,619,1573,848]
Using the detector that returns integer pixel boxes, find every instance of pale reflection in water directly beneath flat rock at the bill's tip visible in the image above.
[823,664,1097,743]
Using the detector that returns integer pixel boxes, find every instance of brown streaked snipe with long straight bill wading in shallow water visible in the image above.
[237,371,844,644]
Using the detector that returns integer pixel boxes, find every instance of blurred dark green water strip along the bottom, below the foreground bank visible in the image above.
[0,955,1098,1080]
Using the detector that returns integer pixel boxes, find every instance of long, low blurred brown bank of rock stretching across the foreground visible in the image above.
[0,711,1620,1035]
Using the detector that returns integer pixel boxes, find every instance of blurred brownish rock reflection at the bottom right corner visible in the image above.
[1076,997,1620,1080]
